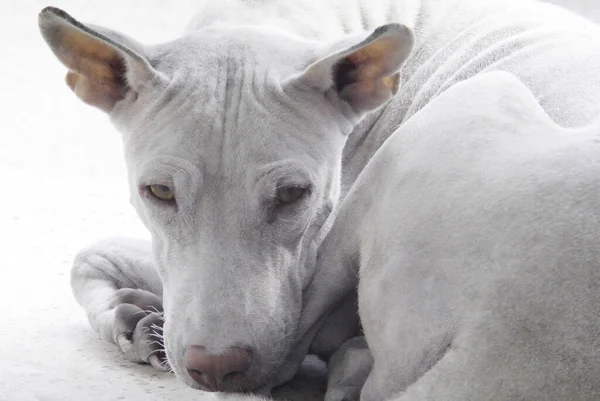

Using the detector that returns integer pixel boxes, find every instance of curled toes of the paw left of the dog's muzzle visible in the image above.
[108,289,170,371]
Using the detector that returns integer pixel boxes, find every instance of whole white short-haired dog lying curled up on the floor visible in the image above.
[39,0,600,400]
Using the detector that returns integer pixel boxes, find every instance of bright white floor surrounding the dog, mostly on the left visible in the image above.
[0,0,600,401]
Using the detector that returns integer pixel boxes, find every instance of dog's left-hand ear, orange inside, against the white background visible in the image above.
[38,7,164,112]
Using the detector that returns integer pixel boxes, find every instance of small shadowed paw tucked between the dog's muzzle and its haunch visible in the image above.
[325,337,373,401]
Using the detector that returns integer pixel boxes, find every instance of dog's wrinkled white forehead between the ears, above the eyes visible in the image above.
[119,28,342,177]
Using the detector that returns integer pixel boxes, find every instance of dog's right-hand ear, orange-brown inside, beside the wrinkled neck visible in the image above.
[300,24,414,114]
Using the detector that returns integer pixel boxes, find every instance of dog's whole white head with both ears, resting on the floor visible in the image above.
[40,9,412,391]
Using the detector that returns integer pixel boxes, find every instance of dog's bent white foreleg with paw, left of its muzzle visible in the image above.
[71,238,168,370]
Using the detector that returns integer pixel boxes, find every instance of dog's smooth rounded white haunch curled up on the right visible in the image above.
[300,72,600,401]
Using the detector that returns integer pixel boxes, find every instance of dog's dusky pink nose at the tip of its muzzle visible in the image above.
[184,345,251,391]
